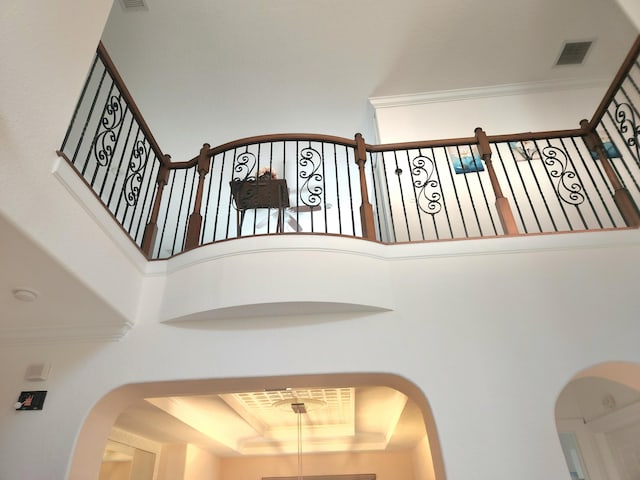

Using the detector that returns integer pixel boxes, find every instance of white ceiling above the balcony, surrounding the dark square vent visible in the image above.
[103,0,637,160]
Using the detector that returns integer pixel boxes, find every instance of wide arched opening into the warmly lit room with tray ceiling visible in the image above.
[70,374,444,480]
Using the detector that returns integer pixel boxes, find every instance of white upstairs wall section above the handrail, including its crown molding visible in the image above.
[371,80,608,143]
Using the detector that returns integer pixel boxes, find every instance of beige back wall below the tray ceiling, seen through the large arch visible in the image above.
[220,452,416,480]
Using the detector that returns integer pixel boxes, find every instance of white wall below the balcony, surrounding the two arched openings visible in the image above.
[0,231,640,480]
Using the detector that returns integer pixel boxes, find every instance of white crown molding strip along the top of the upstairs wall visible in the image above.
[369,78,610,109]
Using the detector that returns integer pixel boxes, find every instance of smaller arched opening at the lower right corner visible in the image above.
[555,362,640,480]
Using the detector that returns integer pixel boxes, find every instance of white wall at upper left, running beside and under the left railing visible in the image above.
[0,0,141,327]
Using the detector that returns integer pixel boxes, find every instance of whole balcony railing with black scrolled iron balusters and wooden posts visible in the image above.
[59,39,640,259]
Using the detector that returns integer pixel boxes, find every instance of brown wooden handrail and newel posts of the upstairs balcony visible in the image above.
[83,36,640,258]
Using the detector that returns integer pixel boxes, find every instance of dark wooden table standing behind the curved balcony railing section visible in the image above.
[229,178,289,236]
